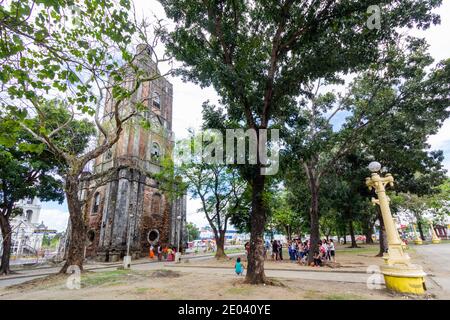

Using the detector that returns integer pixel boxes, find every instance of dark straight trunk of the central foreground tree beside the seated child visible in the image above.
[245,172,266,284]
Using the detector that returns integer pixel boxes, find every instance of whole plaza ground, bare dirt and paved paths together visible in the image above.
[0,243,450,300]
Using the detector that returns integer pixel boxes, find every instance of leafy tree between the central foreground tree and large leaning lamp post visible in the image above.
[284,38,450,262]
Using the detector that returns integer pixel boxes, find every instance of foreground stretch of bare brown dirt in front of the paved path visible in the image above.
[0,270,402,300]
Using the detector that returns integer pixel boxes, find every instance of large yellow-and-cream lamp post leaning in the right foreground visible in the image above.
[366,162,426,294]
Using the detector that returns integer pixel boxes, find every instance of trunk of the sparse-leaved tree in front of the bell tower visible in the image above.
[60,176,87,273]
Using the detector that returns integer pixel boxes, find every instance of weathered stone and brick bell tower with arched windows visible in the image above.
[86,45,186,261]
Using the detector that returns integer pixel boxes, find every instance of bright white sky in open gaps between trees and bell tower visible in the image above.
[40,0,450,231]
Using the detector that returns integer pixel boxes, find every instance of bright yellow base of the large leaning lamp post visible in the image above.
[381,265,426,295]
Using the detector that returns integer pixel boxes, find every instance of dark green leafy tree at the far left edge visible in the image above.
[0,116,64,275]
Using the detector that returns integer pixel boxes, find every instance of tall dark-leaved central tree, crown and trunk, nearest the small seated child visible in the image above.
[160,0,441,284]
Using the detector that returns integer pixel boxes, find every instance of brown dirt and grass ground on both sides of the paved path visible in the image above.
[0,246,428,300]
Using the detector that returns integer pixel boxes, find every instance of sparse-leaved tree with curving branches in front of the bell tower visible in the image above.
[0,0,171,272]
